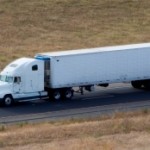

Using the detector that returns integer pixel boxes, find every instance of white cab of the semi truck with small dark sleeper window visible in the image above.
[0,58,47,106]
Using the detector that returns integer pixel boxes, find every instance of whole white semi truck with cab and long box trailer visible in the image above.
[0,43,150,106]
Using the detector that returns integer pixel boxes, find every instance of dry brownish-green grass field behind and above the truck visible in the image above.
[0,0,150,69]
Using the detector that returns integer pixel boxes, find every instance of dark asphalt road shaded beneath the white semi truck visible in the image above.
[0,83,150,124]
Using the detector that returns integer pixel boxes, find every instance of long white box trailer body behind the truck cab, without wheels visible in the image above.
[37,43,150,88]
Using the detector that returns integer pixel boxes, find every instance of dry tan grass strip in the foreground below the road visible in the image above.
[0,110,150,150]
